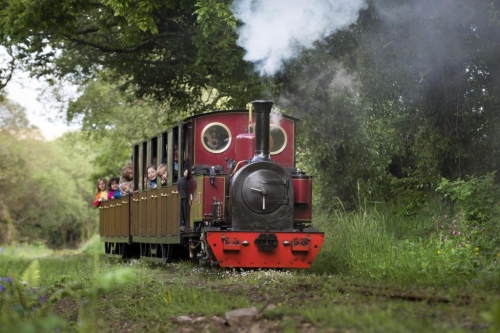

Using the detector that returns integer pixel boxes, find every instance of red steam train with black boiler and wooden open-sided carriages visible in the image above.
[99,101,324,268]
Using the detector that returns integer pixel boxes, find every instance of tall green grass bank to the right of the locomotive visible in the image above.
[312,212,500,291]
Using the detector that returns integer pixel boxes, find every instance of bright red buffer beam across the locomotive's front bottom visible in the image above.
[206,231,324,268]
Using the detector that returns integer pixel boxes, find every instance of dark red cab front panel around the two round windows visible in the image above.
[194,111,295,168]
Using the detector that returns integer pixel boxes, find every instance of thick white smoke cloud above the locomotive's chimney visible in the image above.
[231,0,367,76]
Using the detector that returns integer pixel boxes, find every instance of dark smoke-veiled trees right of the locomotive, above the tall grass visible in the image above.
[280,0,500,210]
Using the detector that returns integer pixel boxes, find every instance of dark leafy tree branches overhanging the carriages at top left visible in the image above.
[0,0,268,112]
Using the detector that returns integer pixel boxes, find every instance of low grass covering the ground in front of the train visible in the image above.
[0,250,495,332]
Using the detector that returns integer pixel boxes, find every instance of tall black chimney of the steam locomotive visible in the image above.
[252,100,274,162]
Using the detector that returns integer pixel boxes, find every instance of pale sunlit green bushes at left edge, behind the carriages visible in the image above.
[0,92,97,247]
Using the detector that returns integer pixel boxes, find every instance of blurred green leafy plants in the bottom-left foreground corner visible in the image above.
[0,260,135,333]
